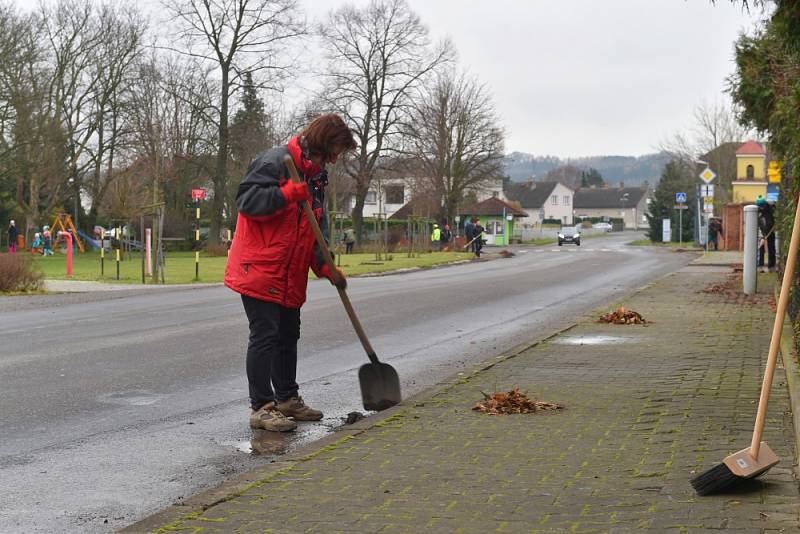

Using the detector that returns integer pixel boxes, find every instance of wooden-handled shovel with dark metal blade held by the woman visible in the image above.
[283,154,402,411]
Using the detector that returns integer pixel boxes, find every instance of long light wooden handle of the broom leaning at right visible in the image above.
[750,200,800,459]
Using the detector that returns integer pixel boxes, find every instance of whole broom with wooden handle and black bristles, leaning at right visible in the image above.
[691,200,800,495]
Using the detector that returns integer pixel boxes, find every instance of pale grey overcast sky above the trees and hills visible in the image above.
[16,0,761,157]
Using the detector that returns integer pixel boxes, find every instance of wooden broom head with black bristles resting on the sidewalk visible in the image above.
[691,441,780,495]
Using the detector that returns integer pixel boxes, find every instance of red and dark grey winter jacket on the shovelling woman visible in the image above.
[225,137,330,308]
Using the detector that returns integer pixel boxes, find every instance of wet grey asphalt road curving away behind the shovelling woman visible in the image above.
[0,233,692,532]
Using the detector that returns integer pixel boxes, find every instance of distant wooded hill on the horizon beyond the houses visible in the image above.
[504,152,670,186]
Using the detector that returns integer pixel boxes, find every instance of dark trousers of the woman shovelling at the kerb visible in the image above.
[242,295,300,410]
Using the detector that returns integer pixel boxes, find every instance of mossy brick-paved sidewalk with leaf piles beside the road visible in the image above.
[130,269,800,533]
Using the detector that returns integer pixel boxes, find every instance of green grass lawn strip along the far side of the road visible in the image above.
[34,252,472,284]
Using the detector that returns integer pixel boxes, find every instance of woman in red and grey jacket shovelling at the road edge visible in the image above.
[225,115,356,432]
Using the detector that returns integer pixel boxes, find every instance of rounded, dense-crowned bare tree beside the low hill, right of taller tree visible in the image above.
[406,70,504,222]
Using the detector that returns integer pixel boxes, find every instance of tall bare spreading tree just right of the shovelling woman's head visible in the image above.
[319,0,453,239]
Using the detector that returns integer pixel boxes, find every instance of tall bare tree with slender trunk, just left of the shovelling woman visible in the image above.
[167,0,306,243]
